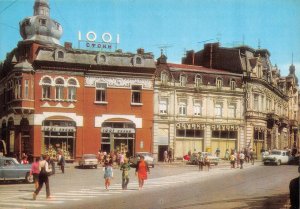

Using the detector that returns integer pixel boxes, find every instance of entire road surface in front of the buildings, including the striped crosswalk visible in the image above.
[0,163,298,209]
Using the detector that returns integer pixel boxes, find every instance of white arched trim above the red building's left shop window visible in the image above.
[33,112,83,127]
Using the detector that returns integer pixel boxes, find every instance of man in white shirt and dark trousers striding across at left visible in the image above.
[33,155,52,200]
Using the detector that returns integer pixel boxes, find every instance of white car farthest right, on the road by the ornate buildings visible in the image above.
[263,150,290,165]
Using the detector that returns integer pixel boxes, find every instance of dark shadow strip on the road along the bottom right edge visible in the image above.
[164,194,290,209]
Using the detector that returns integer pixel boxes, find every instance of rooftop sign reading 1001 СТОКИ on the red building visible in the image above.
[78,31,120,50]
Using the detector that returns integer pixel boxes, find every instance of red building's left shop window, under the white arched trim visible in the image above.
[41,120,76,160]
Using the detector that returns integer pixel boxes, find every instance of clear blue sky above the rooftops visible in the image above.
[0,0,300,78]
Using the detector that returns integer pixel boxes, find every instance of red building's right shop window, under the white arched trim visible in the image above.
[101,122,135,156]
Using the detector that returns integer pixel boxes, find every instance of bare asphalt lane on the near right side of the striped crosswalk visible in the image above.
[52,166,298,209]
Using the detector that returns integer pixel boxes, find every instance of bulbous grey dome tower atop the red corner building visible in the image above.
[20,0,63,44]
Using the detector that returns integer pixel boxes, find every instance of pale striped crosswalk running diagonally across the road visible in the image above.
[0,167,233,209]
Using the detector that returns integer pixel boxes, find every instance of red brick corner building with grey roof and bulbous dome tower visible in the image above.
[0,0,156,159]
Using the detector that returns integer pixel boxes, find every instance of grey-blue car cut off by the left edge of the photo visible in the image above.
[0,157,33,183]
